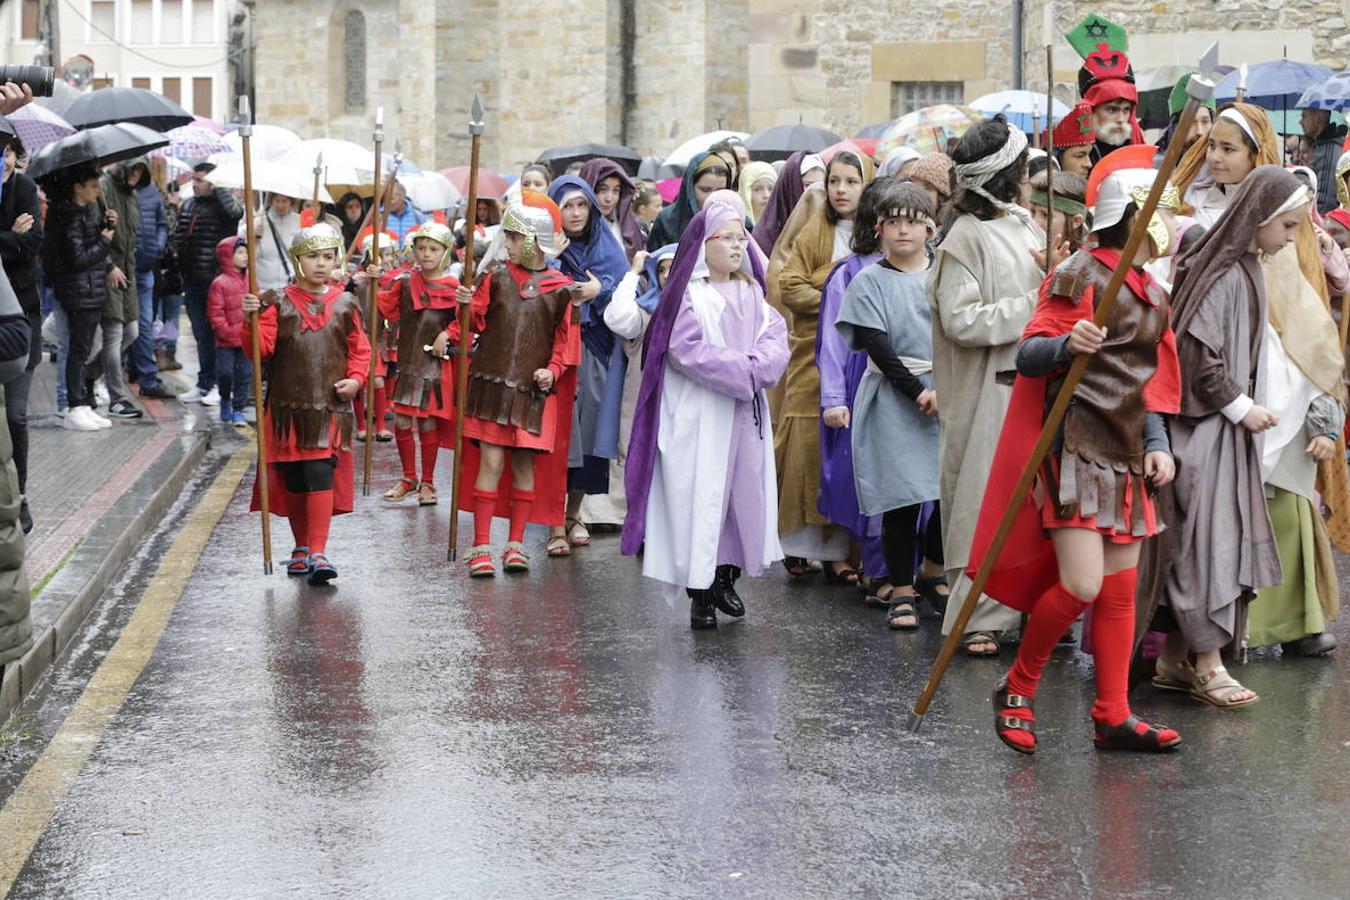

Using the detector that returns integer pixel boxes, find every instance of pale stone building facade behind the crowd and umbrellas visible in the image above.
[254,0,1350,171]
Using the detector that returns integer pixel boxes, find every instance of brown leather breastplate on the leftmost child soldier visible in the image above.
[262,291,360,453]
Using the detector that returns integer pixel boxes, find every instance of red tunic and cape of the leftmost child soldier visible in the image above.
[246,285,370,515]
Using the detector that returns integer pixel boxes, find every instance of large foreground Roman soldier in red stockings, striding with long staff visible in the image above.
[971,148,1181,753]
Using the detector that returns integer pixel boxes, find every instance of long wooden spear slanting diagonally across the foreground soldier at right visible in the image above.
[909,46,1218,731]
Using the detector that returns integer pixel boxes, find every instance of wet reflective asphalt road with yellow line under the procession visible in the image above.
[0,445,1350,900]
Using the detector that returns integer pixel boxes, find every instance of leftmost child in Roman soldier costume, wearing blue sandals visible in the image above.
[240,224,370,584]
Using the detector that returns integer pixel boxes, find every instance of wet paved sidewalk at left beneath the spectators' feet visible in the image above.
[0,329,225,722]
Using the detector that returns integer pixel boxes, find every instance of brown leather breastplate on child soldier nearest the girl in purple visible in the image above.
[464,267,579,434]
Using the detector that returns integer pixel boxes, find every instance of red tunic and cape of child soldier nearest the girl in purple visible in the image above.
[447,262,582,526]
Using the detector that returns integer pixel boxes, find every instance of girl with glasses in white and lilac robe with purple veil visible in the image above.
[622,202,787,629]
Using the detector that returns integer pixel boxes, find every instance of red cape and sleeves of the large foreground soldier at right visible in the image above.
[967,250,1181,613]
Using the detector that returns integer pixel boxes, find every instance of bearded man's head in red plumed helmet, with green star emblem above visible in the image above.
[1065,15,1143,163]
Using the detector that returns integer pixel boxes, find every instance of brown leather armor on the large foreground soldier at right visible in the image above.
[1048,250,1168,475]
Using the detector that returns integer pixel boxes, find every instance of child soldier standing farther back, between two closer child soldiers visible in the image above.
[367,221,459,506]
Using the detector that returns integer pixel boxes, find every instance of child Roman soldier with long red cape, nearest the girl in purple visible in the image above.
[456,192,582,578]
